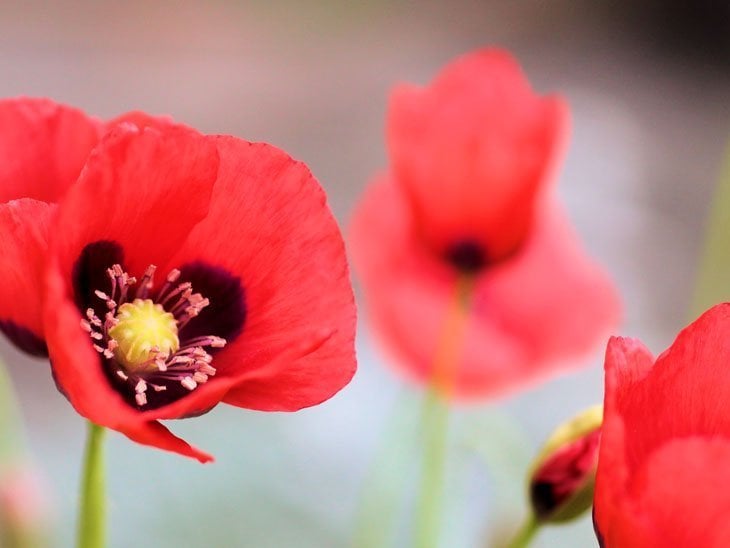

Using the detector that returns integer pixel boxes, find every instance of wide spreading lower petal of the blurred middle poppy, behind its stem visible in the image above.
[351,180,619,398]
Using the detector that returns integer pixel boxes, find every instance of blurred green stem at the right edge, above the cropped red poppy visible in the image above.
[690,146,730,320]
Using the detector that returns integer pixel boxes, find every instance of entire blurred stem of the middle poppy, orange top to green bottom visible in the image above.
[415,276,473,548]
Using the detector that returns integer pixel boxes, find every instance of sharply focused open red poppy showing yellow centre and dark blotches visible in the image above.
[43,124,355,461]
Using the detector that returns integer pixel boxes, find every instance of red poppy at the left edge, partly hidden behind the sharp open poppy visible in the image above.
[0,98,175,356]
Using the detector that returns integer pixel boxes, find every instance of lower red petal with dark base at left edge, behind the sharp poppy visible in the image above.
[0,198,55,354]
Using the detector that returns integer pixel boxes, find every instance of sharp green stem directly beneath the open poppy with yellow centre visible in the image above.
[78,422,106,548]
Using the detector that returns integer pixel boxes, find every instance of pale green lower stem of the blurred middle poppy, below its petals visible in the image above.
[416,387,449,548]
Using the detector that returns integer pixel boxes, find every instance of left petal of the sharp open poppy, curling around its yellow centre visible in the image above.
[44,125,218,460]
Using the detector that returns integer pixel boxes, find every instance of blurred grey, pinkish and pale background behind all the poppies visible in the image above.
[0,0,730,548]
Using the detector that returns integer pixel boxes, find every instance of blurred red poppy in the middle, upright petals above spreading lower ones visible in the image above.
[350,50,619,398]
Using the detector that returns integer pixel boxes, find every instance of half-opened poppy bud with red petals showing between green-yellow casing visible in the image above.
[529,405,603,523]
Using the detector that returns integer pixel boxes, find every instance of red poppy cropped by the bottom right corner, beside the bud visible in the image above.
[594,304,730,548]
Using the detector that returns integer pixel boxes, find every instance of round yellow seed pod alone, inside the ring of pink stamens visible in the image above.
[109,299,180,371]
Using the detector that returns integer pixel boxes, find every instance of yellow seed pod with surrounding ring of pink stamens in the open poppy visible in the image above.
[81,264,226,408]
